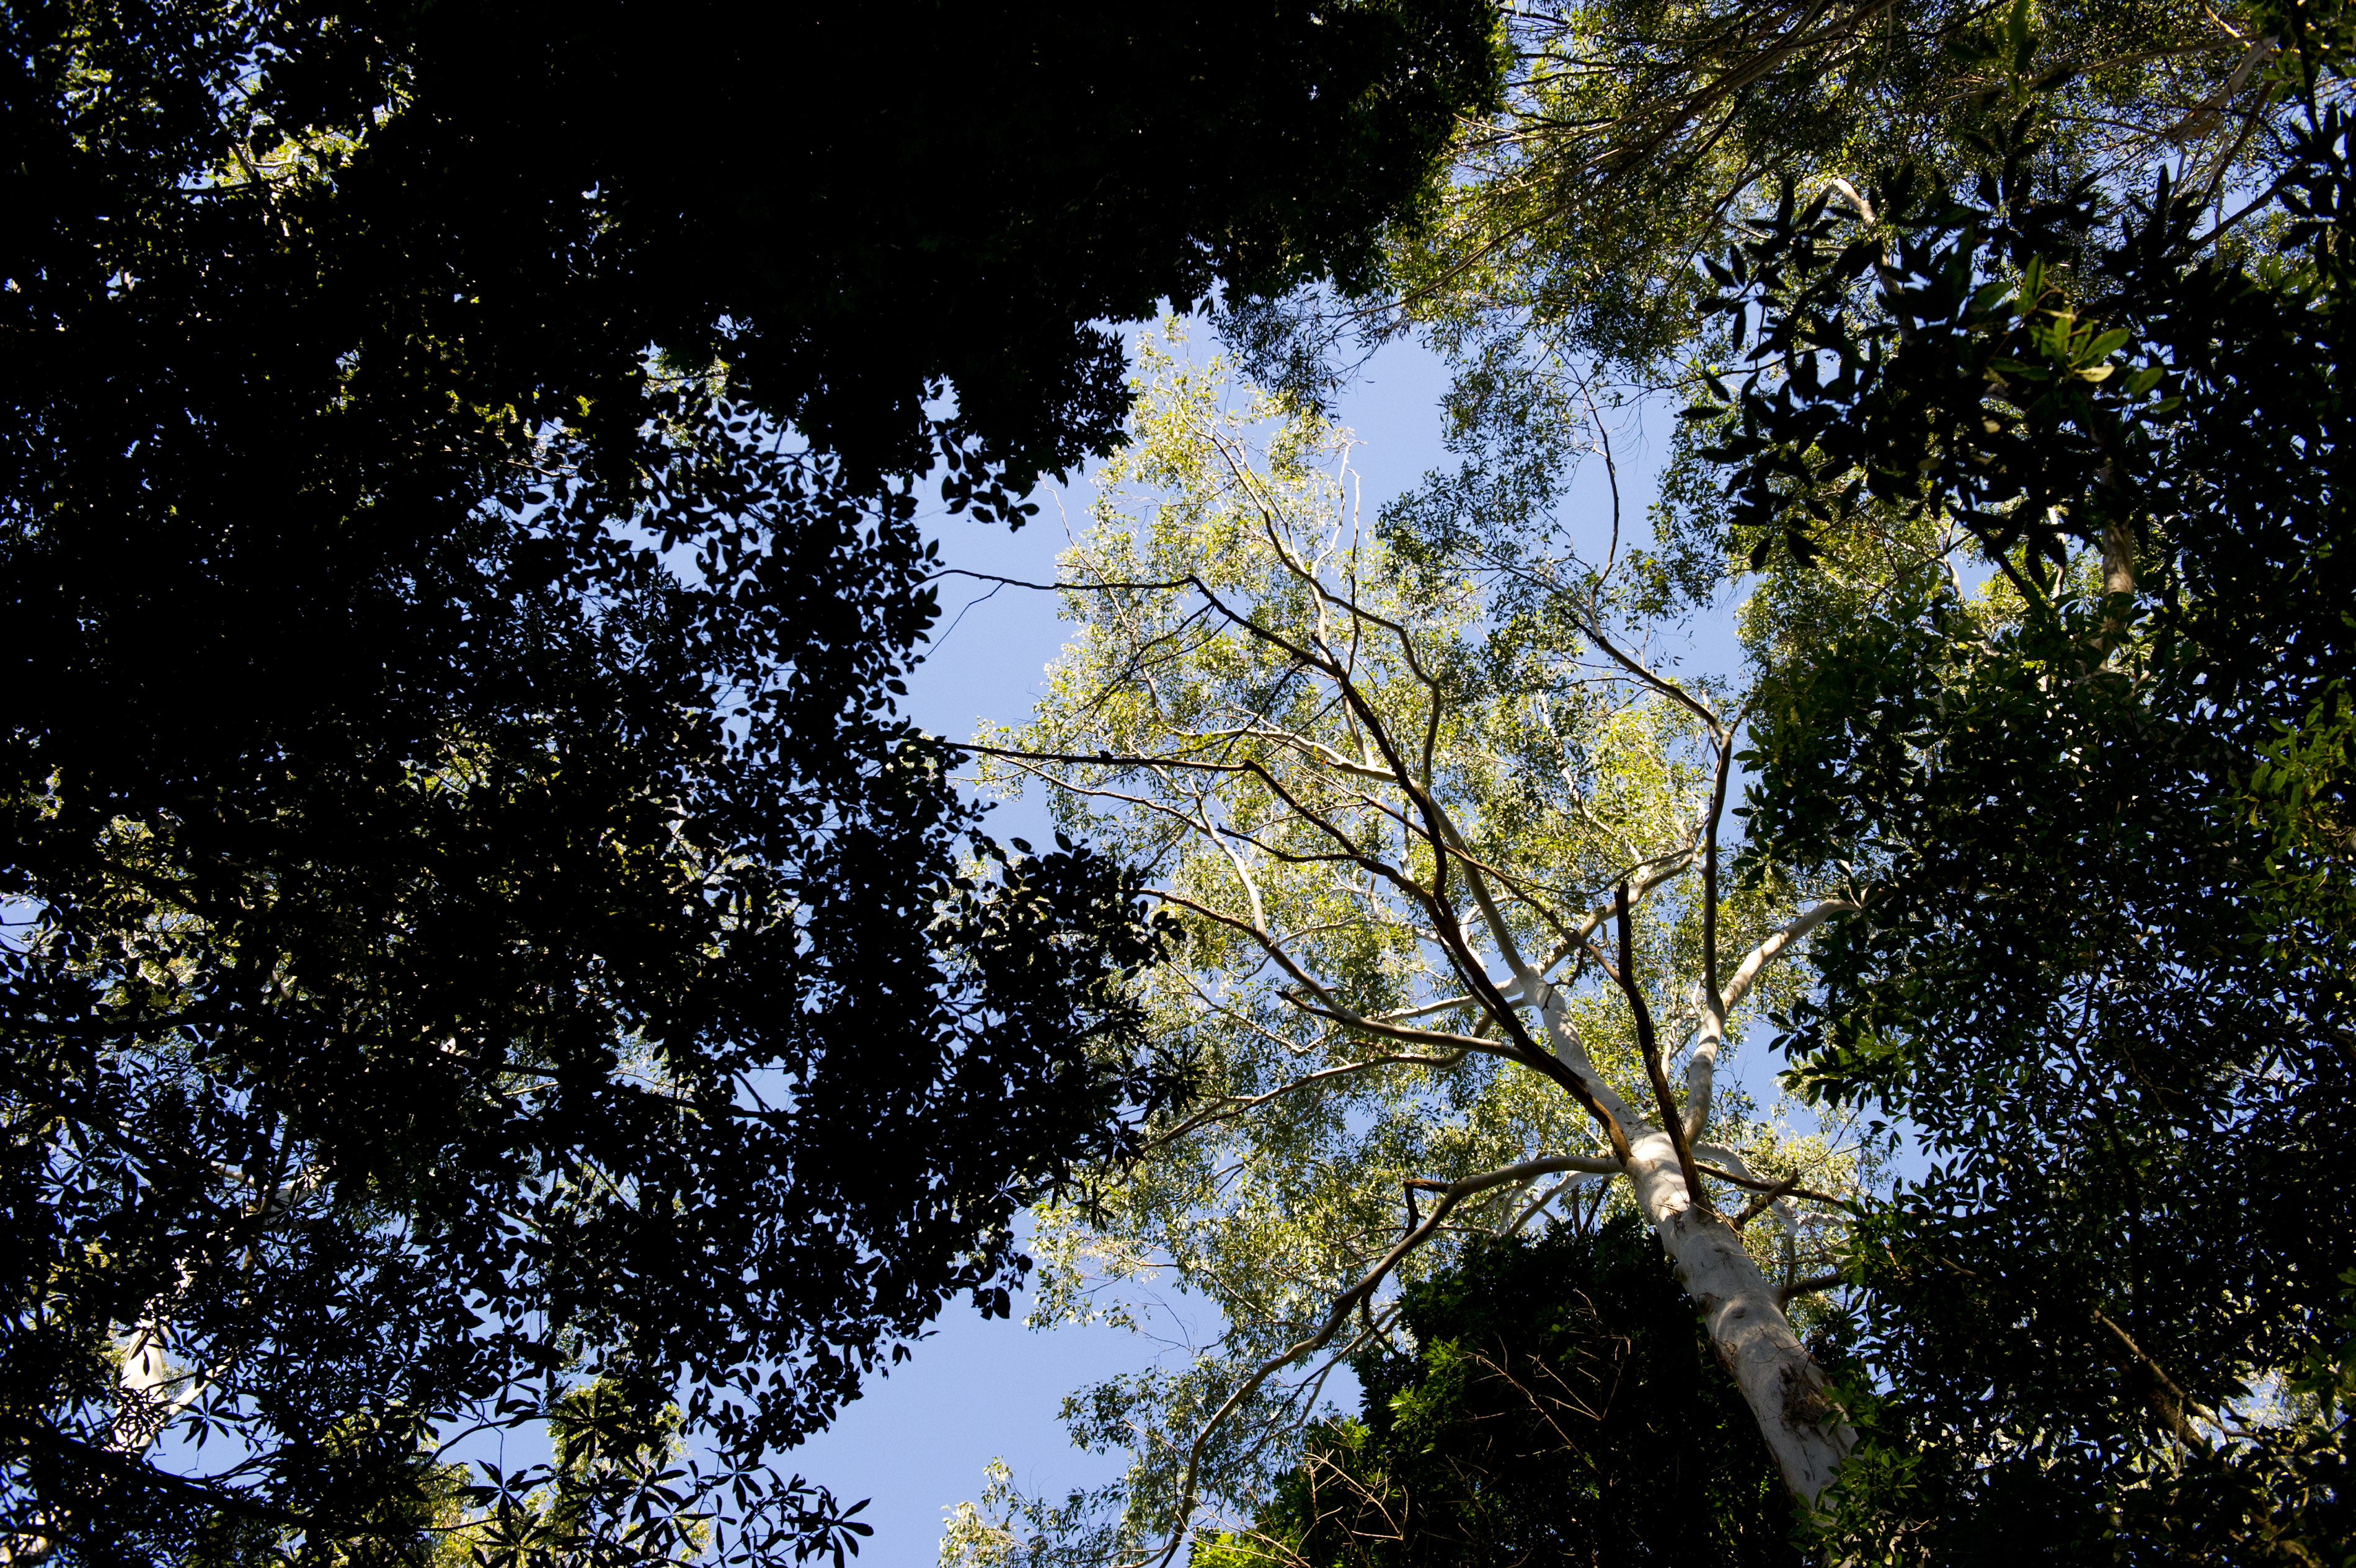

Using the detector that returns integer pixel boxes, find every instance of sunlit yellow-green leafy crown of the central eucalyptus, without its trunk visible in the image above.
[959,339,1856,1561]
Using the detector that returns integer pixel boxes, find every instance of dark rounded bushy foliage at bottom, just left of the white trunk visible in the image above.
[1195,1217,1807,1568]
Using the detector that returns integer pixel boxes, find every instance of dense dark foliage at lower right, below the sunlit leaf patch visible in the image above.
[1753,593,2356,1563]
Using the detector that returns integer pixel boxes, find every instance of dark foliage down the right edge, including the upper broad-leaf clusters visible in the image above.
[1717,12,2356,1563]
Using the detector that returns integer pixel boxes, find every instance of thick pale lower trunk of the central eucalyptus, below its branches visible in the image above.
[1628,1128,1856,1507]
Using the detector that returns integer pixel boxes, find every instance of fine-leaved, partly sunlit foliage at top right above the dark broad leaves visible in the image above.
[1220,0,2295,593]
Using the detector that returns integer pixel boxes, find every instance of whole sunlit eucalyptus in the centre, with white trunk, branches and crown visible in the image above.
[952,343,1859,1561]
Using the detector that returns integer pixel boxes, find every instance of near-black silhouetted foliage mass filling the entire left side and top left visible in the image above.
[0,0,1494,1561]
